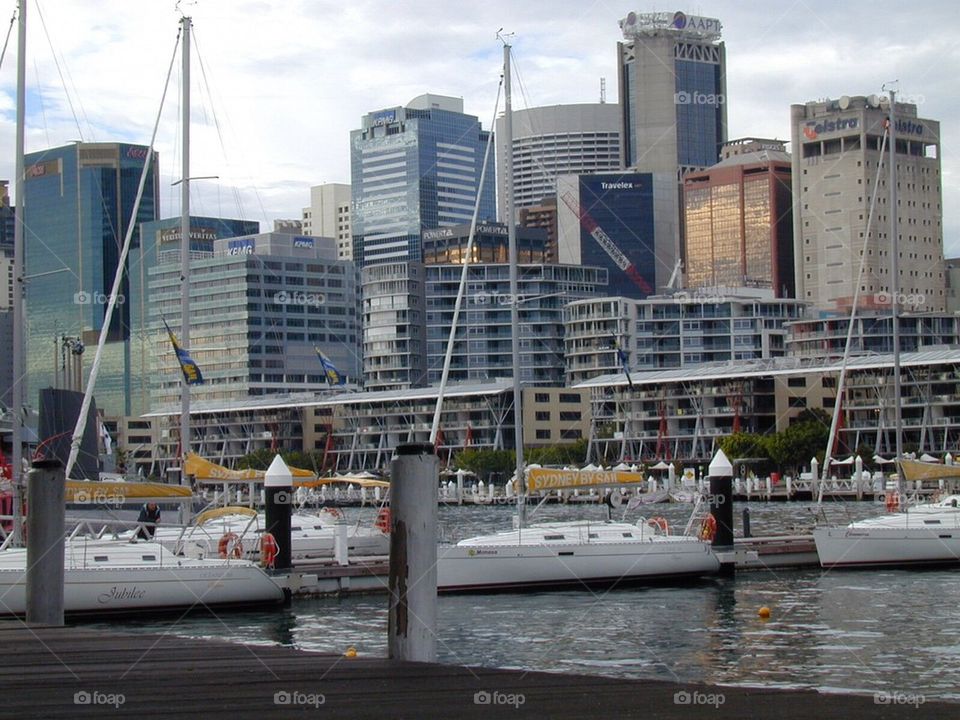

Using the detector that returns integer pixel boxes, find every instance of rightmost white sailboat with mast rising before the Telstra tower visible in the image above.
[813,91,960,568]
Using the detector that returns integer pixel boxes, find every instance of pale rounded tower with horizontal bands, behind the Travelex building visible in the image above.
[496,103,621,222]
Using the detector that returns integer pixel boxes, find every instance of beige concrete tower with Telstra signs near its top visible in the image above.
[790,95,946,312]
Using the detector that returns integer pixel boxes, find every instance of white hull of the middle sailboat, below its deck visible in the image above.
[437,538,720,592]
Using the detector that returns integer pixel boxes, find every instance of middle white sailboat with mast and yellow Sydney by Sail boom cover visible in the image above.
[437,42,720,592]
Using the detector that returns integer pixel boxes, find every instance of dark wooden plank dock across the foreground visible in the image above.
[0,622,960,720]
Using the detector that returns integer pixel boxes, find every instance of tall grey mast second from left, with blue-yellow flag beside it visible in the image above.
[180,16,191,478]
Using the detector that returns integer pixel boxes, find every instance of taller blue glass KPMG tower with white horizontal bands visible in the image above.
[350,94,496,267]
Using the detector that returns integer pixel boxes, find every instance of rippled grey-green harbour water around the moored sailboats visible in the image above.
[86,502,960,701]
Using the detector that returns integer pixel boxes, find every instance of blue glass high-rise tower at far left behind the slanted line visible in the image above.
[24,143,158,415]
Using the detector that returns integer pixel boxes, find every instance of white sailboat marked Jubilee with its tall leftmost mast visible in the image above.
[0,14,284,615]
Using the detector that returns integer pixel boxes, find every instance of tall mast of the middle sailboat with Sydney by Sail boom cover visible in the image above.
[503,43,527,528]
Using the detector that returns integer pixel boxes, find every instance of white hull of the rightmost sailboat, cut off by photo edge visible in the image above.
[813,527,960,568]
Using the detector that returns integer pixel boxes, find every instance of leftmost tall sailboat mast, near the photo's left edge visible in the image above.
[10,0,27,545]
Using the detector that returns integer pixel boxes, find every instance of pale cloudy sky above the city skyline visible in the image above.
[0,0,960,257]
